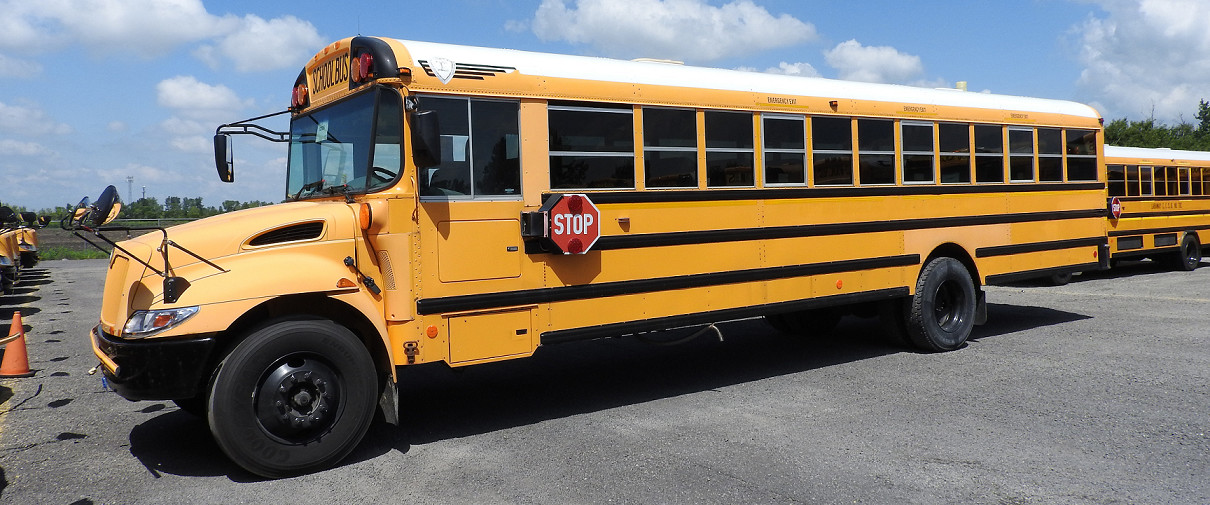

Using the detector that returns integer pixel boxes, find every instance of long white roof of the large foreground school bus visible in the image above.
[397,40,1101,119]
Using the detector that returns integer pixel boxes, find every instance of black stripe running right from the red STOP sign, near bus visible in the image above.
[593,208,1105,251]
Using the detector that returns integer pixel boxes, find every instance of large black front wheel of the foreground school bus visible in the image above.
[208,320,378,478]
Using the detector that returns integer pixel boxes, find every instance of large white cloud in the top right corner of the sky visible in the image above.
[1076,0,1210,124]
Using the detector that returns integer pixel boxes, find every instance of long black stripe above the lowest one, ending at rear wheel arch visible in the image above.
[416,254,920,315]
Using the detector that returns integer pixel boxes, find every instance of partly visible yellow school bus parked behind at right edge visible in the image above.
[1105,145,1210,270]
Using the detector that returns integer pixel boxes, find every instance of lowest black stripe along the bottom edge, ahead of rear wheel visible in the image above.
[541,287,908,345]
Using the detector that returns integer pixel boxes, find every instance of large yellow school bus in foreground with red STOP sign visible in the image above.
[86,36,1107,476]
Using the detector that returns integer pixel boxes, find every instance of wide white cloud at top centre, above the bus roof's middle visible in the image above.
[529,0,816,62]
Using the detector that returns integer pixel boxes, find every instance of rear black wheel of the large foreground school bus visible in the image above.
[906,258,975,352]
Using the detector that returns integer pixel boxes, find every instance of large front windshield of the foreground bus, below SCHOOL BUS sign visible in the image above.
[286,88,403,199]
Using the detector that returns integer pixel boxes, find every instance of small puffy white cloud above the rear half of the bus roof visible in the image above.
[824,40,924,84]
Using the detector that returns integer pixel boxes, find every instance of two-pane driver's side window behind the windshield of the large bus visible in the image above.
[420,96,520,197]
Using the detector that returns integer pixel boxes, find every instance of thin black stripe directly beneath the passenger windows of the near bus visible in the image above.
[580,182,1105,205]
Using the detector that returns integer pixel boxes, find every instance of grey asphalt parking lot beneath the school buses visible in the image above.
[0,260,1210,504]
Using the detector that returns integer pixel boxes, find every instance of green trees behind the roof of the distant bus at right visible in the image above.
[1105,99,1210,151]
